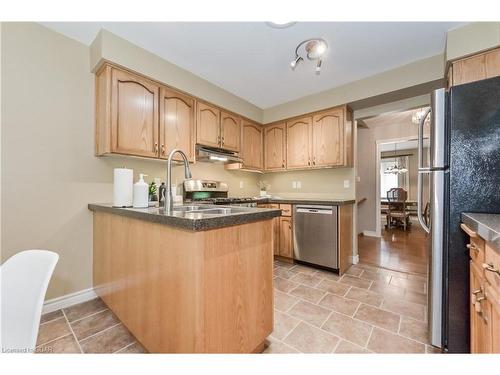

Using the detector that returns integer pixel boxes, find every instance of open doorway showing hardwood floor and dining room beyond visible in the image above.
[357,108,428,276]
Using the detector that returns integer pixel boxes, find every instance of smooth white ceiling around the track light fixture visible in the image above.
[43,22,462,109]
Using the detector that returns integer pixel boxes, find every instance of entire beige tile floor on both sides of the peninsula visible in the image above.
[37,261,440,353]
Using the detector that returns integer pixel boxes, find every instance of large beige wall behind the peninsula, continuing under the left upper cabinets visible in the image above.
[1,23,258,298]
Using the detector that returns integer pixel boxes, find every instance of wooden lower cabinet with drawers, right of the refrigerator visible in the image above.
[461,224,500,353]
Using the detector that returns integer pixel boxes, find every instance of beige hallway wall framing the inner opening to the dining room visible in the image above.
[356,122,428,233]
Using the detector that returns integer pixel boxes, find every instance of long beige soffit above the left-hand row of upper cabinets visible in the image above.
[90,30,262,122]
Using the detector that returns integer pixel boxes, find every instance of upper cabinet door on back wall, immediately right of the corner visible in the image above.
[264,123,286,171]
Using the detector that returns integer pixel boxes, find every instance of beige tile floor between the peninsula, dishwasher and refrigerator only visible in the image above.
[265,261,437,353]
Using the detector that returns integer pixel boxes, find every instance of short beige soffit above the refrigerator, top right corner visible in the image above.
[446,22,500,61]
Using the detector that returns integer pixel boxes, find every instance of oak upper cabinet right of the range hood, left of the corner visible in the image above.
[241,121,264,170]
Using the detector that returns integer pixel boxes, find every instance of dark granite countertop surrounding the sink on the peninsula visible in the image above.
[88,203,281,231]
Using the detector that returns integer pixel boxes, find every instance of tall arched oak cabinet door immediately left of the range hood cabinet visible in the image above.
[160,87,195,162]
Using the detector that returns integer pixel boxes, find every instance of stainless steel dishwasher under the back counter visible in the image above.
[293,205,338,269]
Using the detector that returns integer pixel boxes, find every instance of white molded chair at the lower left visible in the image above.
[0,250,59,353]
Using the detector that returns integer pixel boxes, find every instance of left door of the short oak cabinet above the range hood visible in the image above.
[196,102,220,147]
